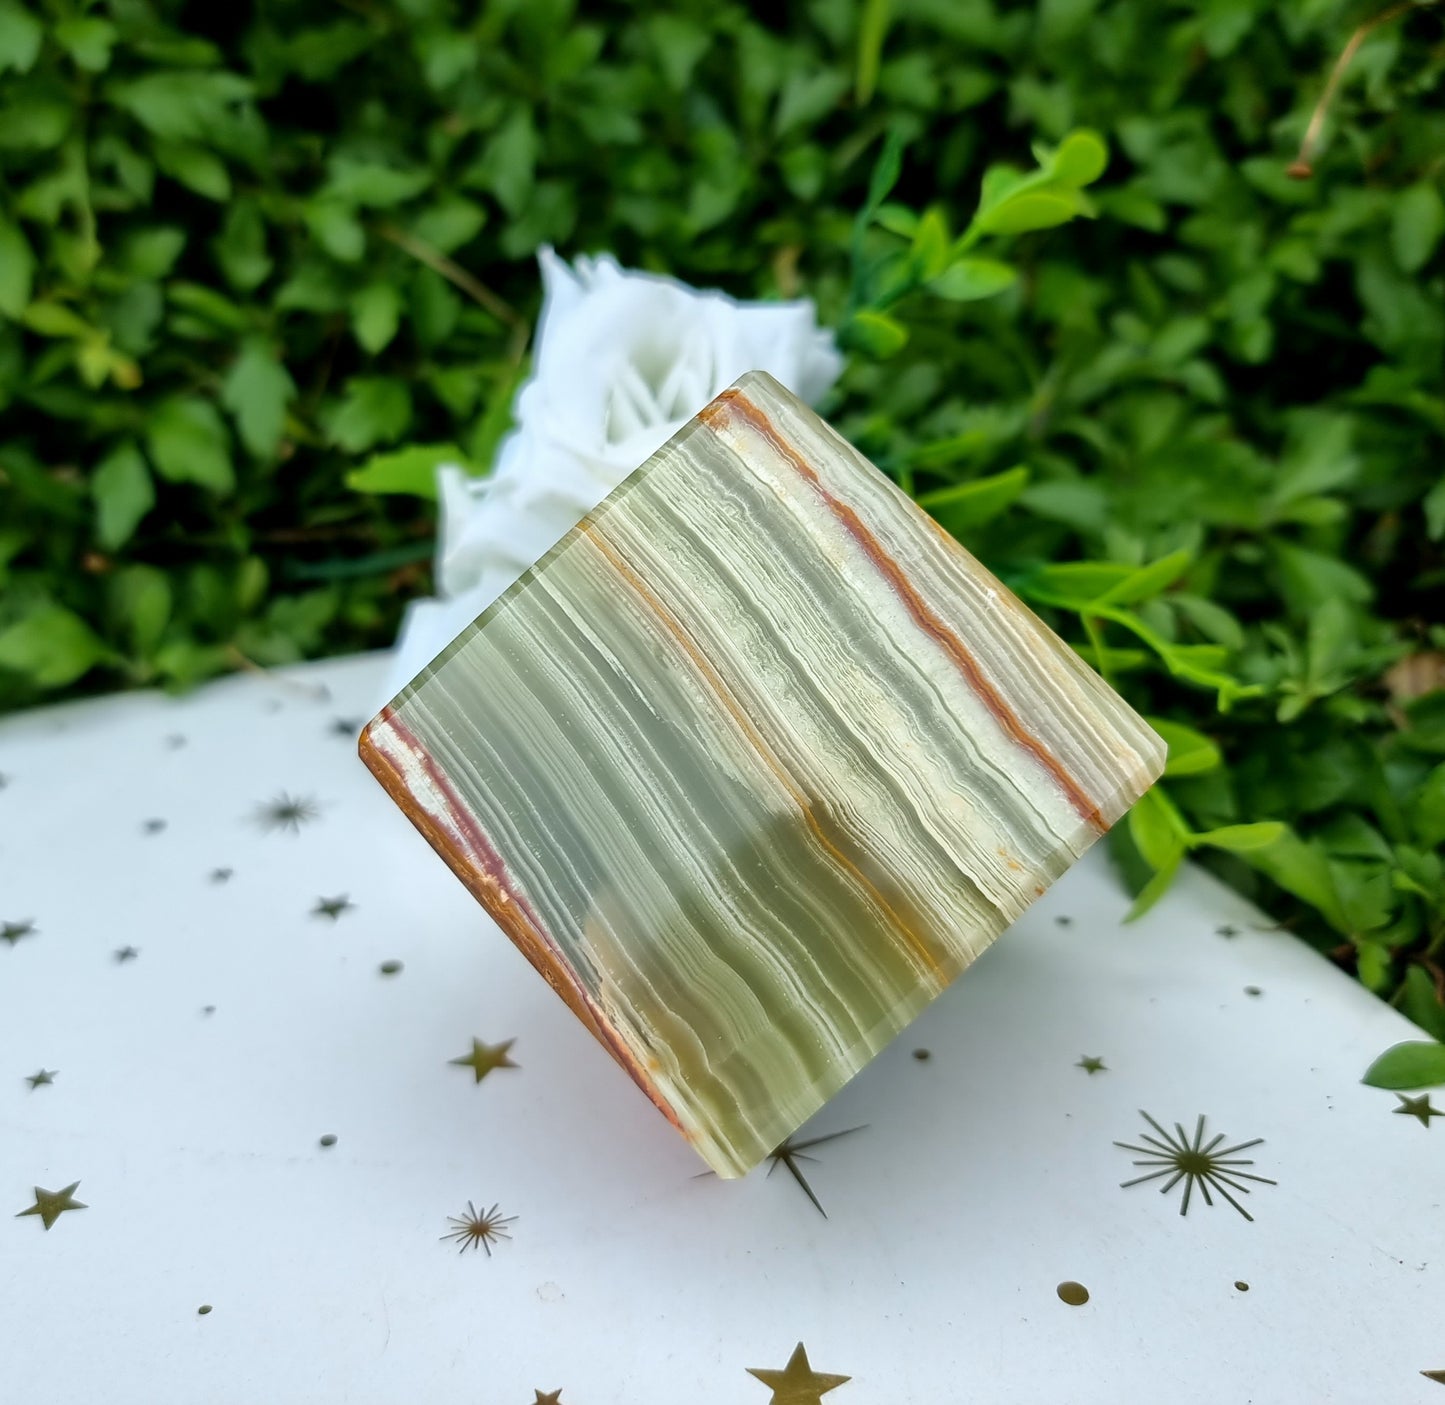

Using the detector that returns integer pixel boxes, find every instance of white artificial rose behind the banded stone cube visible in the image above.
[390,249,842,692]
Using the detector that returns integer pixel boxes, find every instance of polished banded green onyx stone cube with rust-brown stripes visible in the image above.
[361,371,1165,1175]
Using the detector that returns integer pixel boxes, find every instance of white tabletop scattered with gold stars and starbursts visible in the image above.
[0,658,1445,1405]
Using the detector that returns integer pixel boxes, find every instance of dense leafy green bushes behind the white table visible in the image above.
[0,0,1445,1036]
